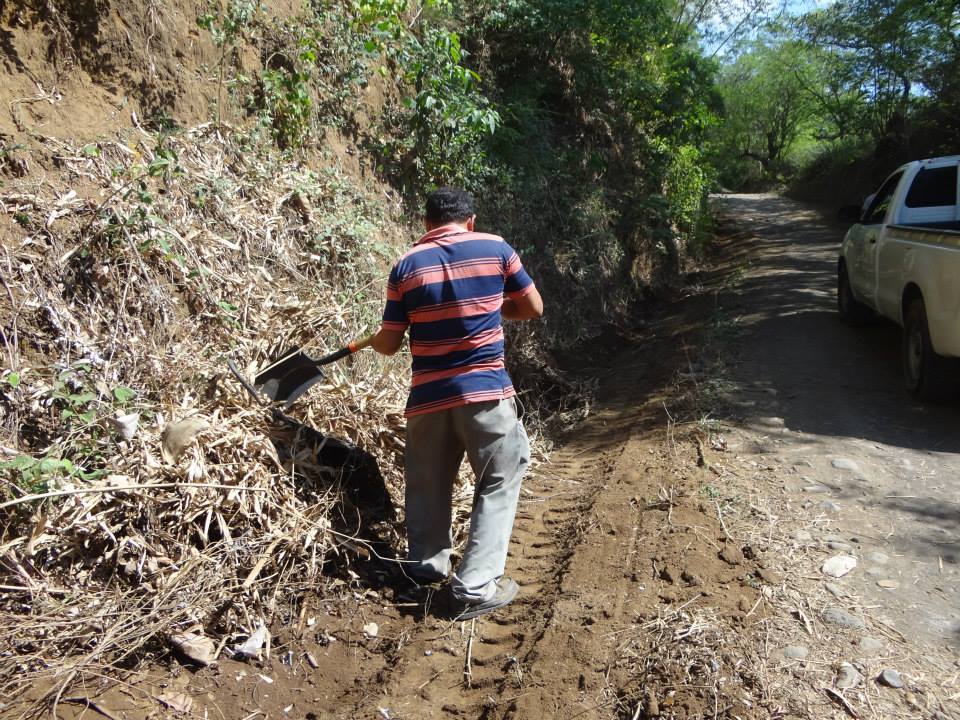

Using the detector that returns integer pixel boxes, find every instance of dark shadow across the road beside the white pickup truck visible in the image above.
[724,191,960,453]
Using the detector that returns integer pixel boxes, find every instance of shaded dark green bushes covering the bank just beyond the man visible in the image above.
[450,0,719,345]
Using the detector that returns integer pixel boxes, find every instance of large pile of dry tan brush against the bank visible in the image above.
[0,125,410,702]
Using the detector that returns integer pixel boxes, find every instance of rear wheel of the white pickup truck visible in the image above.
[901,300,960,402]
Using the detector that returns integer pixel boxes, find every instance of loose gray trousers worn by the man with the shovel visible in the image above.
[404,398,530,603]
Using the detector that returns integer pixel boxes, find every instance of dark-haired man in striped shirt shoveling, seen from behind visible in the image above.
[371,188,543,619]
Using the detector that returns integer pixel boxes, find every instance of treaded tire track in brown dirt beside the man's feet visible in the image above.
[344,436,624,718]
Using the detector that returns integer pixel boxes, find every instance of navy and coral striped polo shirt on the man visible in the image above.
[383,225,534,417]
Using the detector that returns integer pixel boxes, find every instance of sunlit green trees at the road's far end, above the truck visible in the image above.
[716,0,960,194]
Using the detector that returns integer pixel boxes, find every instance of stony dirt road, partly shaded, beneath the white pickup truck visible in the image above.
[722,195,960,650]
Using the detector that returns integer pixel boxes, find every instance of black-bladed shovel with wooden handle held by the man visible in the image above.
[227,335,373,411]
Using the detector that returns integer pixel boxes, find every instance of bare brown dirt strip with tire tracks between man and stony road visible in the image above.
[338,297,776,720]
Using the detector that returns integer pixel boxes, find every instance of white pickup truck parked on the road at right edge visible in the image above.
[837,156,960,400]
